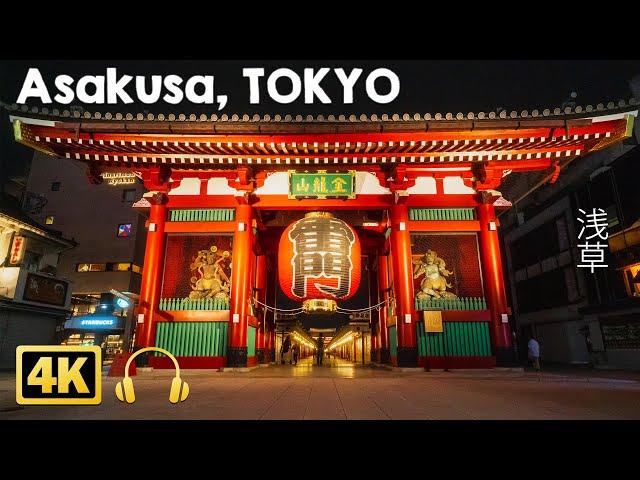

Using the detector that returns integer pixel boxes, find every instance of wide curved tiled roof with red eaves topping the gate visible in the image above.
[5,99,638,170]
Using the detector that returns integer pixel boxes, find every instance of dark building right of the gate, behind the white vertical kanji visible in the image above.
[501,114,640,369]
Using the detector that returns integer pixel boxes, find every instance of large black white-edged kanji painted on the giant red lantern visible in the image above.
[289,217,355,298]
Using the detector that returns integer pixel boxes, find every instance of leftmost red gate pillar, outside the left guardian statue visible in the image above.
[135,193,168,348]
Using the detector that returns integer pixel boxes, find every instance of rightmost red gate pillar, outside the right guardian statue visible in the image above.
[477,203,513,363]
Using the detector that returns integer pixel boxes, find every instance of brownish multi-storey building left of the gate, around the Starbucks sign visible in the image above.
[25,152,146,358]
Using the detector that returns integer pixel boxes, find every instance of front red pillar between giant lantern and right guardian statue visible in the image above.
[389,204,418,367]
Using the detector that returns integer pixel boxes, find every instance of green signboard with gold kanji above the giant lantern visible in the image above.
[289,170,356,198]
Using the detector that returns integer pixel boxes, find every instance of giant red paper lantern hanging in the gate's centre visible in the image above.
[278,212,361,312]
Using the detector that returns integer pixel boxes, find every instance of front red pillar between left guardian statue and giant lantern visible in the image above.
[227,204,253,368]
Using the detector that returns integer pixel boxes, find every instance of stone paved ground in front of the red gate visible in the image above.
[0,359,640,420]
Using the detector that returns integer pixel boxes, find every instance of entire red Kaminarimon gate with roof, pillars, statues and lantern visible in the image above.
[11,103,636,368]
